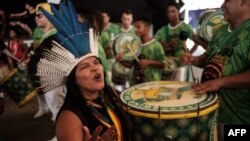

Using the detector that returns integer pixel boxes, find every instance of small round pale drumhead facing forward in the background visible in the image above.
[113,33,141,61]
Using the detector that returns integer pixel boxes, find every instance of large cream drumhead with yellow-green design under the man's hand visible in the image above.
[120,81,218,114]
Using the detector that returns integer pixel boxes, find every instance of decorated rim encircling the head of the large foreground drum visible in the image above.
[120,81,218,114]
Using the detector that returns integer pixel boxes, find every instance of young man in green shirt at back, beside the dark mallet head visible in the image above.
[155,2,198,65]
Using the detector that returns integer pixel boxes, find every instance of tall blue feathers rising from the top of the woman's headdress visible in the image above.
[42,0,93,58]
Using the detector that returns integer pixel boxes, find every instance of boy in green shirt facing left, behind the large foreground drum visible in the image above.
[116,17,165,86]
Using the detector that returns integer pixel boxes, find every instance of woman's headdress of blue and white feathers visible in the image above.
[28,0,98,93]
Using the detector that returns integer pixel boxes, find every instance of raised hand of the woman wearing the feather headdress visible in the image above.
[83,126,117,141]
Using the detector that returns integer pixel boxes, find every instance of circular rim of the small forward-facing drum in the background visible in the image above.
[113,32,141,61]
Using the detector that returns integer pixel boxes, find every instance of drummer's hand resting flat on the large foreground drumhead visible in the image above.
[192,79,223,93]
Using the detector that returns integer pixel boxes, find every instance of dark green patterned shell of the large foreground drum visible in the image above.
[124,105,217,141]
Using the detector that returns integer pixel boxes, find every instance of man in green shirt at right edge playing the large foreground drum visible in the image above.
[183,0,250,140]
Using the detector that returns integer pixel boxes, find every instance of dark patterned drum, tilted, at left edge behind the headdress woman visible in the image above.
[0,69,37,107]
